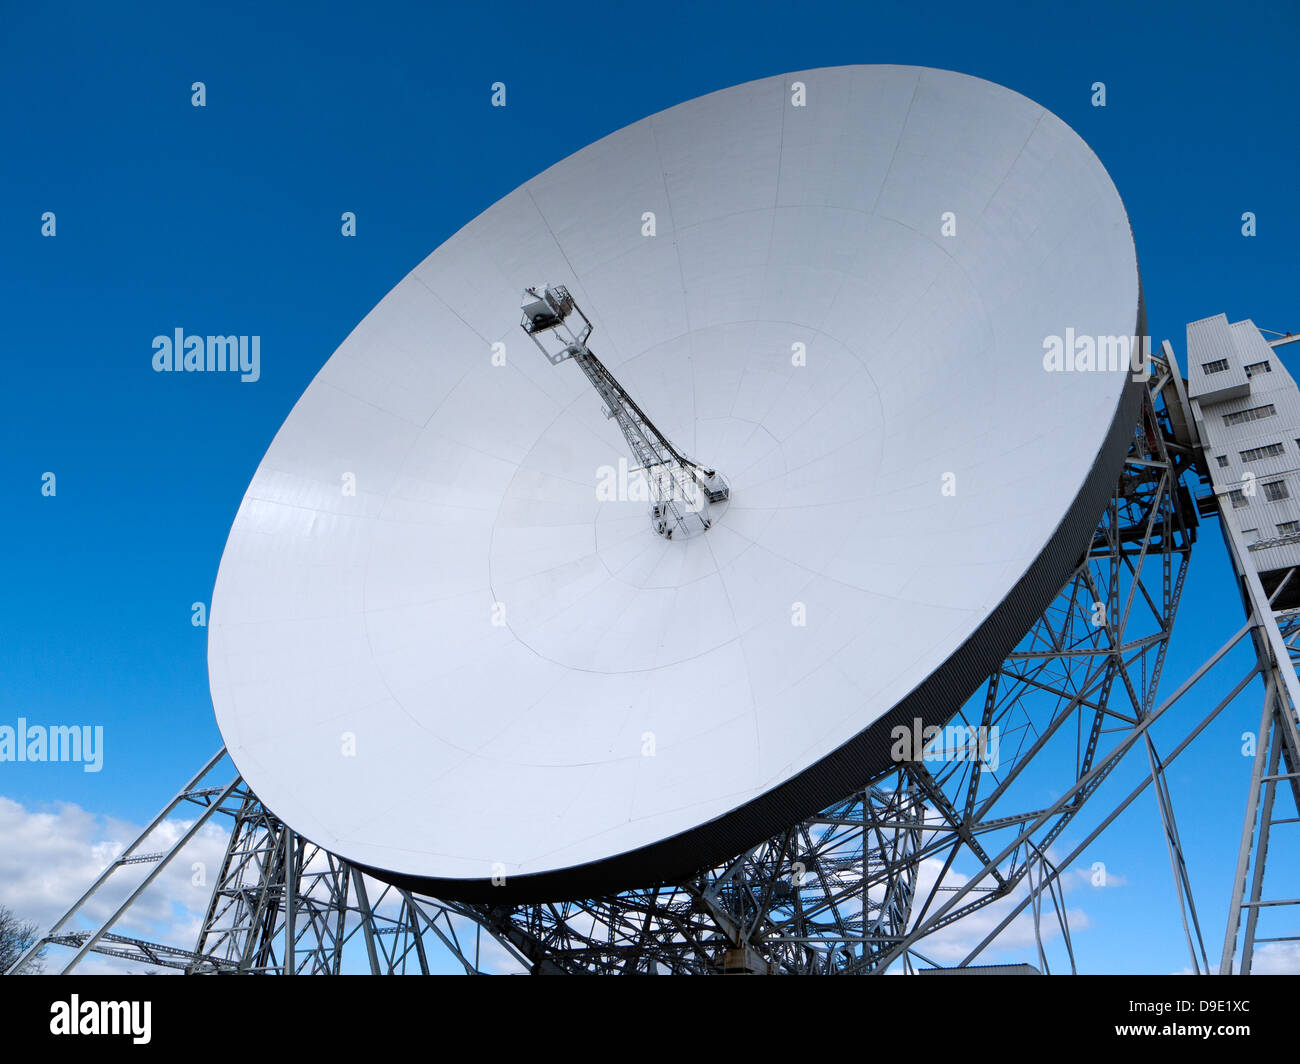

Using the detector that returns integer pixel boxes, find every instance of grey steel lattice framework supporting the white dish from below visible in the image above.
[7,359,1300,974]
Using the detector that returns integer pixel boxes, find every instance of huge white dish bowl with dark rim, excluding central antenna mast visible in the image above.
[208,66,1143,898]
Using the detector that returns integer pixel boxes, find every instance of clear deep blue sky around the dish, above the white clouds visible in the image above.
[0,3,1300,970]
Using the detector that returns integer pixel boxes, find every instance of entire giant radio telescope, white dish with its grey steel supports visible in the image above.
[22,68,1300,974]
